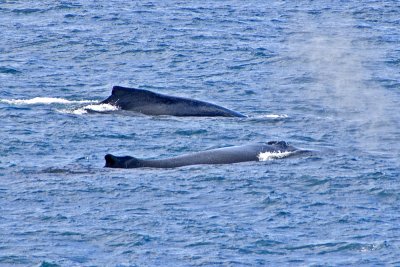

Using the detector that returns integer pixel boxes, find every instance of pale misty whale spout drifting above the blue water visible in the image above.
[287,12,400,154]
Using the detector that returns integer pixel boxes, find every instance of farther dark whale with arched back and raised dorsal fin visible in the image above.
[101,86,246,117]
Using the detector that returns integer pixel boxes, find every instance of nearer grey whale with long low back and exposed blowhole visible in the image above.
[105,141,308,168]
